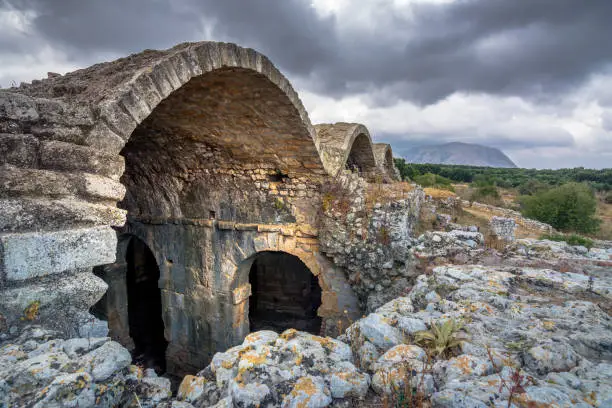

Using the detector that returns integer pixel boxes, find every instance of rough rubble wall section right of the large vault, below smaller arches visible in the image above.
[319,172,425,310]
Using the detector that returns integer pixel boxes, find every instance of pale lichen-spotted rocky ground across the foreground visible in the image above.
[0,233,612,408]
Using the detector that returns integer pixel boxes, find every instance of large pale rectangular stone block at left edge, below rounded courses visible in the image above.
[0,227,117,281]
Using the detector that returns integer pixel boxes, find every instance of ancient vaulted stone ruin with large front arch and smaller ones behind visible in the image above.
[0,42,408,374]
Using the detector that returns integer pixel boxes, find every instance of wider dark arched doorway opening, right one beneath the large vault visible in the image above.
[249,252,321,334]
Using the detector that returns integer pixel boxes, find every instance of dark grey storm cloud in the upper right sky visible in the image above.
[314,0,612,103]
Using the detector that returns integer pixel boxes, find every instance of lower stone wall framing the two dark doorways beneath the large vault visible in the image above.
[96,218,360,373]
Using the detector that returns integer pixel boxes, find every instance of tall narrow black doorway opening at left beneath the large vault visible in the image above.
[126,237,168,372]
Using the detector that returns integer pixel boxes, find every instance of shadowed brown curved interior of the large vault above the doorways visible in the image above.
[120,68,319,221]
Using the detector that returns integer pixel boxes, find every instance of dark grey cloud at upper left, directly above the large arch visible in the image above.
[5,0,335,74]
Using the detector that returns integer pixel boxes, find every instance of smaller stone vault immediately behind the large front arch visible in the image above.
[315,122,377,177]
